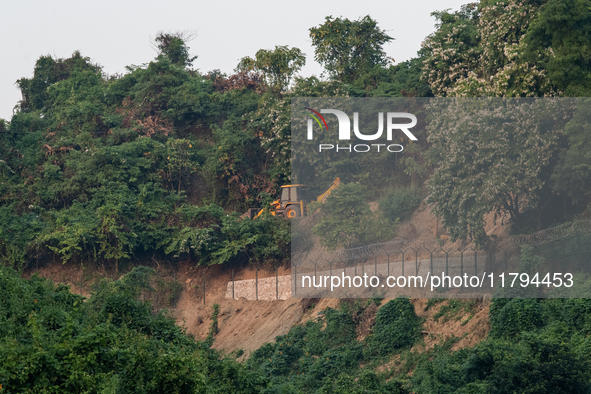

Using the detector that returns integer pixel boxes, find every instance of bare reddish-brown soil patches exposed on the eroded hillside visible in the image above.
[26,203,508,369]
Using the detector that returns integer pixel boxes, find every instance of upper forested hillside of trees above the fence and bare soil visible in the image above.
[0,0,591,267]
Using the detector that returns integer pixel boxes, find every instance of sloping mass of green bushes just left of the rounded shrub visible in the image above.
[247,305,405,393]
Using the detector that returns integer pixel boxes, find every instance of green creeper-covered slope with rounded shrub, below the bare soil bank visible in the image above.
[246,298,420,394]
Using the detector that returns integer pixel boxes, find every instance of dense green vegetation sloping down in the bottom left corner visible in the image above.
[0,267,266,393]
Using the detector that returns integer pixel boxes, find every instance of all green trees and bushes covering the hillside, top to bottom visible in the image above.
[0,0,591,393]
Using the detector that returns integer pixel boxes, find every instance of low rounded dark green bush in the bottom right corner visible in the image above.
[412,334,591,394]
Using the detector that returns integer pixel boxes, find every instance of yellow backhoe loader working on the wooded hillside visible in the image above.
[242,177,341,219]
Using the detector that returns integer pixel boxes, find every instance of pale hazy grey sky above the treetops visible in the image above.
[0,0,469,120]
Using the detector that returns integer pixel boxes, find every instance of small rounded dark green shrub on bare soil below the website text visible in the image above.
[367,298,421,355]
